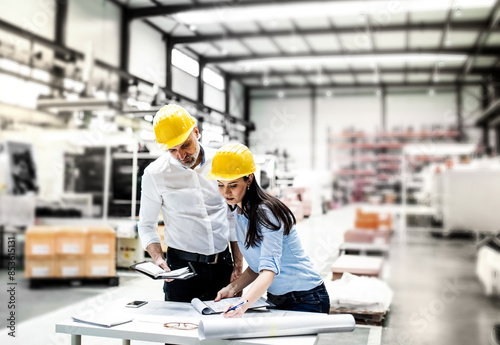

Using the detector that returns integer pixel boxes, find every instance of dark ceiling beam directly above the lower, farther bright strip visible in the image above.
[206,47,499,64]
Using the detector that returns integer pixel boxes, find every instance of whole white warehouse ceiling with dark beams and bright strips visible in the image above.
[113,0,500,89]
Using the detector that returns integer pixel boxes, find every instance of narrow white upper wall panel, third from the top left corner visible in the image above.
[128,20,167,87]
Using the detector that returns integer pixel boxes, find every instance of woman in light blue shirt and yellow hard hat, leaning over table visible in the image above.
[208,144,330,317]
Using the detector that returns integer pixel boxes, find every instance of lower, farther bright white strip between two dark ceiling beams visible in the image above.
[236,54,467,67]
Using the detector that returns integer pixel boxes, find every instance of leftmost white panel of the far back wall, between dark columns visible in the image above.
[250,97,311,170]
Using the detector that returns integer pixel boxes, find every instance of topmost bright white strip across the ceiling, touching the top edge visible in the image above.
[173,0,495,25]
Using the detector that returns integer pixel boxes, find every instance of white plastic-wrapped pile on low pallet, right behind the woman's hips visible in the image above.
[325,272,393,313]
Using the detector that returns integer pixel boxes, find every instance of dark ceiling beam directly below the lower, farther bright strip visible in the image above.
[226,67,498,79]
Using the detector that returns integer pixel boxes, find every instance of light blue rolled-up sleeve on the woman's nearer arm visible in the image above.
[258,208,284,276]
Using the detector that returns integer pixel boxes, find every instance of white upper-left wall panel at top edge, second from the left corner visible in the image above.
[66,0,121,67]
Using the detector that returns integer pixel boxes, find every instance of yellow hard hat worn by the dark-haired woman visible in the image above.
[207,144,257,181]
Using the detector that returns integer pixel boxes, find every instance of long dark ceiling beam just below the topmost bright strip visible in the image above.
[172,21,500,45]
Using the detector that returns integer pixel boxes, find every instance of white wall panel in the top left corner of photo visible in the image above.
[0,0,56,40]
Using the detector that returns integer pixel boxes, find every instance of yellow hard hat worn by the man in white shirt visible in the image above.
[153,104,196,150]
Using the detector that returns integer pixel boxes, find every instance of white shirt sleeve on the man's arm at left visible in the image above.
[137,170,161,249]
